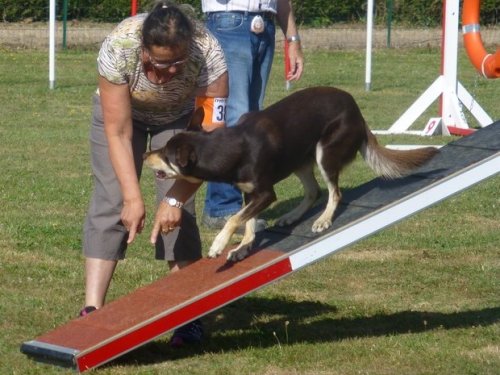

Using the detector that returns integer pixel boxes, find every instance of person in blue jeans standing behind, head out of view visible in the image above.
[202,0,304,229]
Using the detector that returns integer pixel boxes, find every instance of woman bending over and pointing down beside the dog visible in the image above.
[80,1,228,343]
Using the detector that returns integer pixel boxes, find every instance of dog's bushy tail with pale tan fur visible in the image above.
[360,128,439,178]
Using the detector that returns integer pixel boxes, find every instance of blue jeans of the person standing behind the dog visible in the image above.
[204,12,276,217]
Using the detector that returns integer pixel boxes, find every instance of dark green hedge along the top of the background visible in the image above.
[0,0,500,27]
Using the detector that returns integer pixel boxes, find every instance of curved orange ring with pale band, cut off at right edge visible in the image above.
[462,0,500,78]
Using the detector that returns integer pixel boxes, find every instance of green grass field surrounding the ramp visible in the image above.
[0,44,500,375]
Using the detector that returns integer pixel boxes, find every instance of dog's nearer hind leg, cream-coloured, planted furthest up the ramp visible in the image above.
[312,144,342,233]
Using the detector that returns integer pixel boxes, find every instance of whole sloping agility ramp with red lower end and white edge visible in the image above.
[21,121,500,372]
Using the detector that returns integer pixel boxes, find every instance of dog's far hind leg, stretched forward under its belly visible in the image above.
[276,162,320,227]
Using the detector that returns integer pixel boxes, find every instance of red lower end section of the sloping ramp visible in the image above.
[21,250,291,371]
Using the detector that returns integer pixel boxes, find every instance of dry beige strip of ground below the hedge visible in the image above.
[0,21,500,50]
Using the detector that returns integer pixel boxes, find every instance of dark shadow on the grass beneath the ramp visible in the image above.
[111,297,500,367]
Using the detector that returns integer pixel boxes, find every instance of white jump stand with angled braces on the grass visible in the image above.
[374,0,493,135]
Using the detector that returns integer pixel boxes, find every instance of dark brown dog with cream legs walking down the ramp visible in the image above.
[144,87,438,261]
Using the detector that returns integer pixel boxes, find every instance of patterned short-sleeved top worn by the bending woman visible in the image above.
[97,14,227,125]
